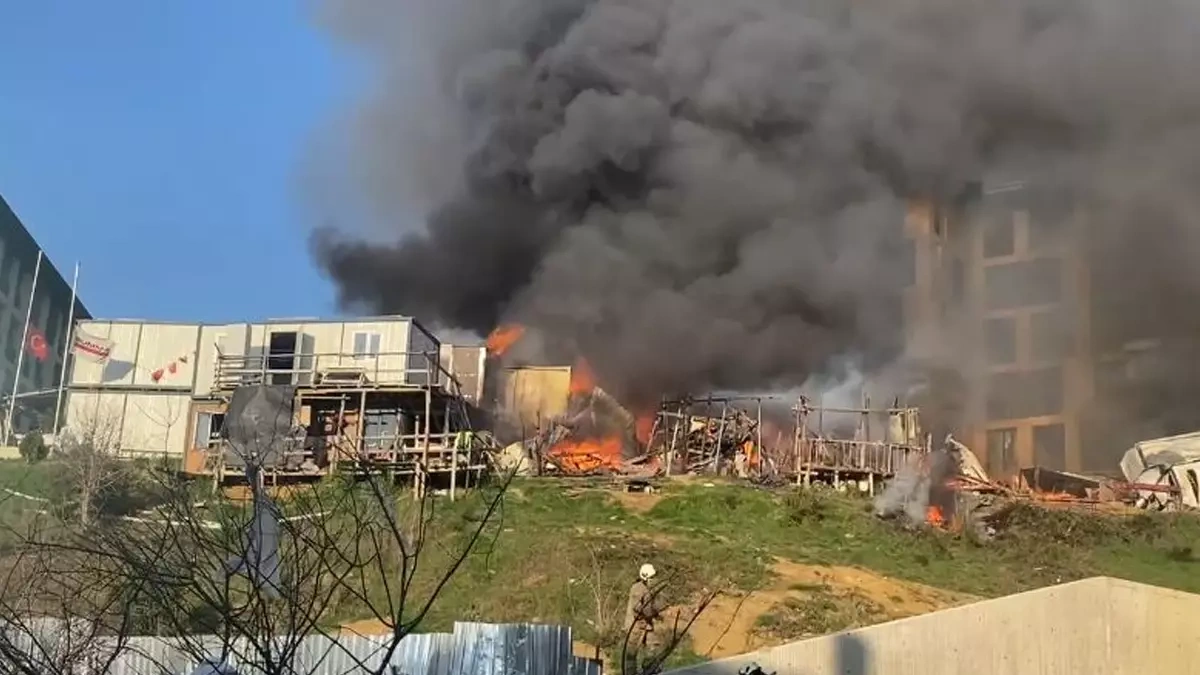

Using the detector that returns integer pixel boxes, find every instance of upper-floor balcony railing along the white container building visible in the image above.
[214,352,460,394]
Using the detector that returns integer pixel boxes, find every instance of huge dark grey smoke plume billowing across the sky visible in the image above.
[313,0,1200,395]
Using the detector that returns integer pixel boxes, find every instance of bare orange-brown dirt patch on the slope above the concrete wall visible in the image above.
[691,560,974,658]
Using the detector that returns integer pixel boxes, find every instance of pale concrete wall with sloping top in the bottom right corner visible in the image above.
[672,578,1200,675]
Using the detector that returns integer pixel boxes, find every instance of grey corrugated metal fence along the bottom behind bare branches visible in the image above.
[0,620,602,675]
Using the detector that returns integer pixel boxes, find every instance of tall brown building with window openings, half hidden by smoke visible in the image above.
[904,180,1200,477]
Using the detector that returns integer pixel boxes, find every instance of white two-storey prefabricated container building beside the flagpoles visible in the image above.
[65,316,442,455]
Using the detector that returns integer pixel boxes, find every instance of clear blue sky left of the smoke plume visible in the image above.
[0,0,353,321]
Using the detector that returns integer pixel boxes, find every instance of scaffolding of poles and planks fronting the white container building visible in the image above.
[204,352,492,496]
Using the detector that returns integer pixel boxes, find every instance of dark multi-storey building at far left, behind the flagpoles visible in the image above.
[0,192,91,431]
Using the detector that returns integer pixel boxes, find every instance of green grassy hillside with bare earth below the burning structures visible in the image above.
[0,465,1200,663]
